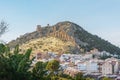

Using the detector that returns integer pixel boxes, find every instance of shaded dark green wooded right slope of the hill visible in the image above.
[75,30,120,54]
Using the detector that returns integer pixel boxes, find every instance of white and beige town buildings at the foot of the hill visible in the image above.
[32,49,120,80]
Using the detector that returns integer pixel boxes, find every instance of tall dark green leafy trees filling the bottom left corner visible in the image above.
[0,44,32,80]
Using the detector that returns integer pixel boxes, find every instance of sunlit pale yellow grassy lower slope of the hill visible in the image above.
[20,37,79,53]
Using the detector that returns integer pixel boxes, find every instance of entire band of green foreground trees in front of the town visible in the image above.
[0,44,94,80]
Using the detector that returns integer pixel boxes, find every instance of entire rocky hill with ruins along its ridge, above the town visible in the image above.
[8,21,120,54]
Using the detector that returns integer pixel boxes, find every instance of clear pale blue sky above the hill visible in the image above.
[0,0,120,46]
